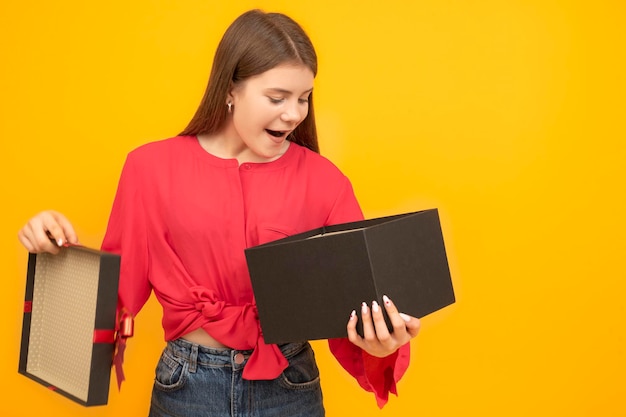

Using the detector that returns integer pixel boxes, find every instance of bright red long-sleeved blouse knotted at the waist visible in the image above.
[102,136,409,407]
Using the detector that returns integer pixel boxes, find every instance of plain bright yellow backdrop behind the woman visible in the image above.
[0,0,626,417]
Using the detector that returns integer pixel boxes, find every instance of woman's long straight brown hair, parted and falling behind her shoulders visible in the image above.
[180,10,319,152]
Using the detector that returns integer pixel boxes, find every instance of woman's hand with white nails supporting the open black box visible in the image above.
[348,296,420,358]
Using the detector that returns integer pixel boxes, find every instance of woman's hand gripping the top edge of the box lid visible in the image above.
[17,210,78,254]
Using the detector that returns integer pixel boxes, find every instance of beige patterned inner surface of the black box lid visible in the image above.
[26,250,100,401]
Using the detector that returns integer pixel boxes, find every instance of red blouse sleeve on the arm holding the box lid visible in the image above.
[102,153,151,317]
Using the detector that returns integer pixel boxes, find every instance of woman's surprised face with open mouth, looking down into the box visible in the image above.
[229,65,314,161]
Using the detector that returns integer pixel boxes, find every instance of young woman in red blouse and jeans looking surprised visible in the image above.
[19,10,419,417]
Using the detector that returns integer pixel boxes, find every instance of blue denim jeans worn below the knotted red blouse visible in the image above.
[150,339,324,417]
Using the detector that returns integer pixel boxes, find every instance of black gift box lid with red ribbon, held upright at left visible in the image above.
[18,246,120,406]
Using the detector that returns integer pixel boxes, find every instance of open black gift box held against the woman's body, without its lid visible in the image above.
[245,209,455,343]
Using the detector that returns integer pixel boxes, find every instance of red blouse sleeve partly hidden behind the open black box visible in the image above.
[328,176,410,408]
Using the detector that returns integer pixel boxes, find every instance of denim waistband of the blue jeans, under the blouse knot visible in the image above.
[165,339,309,369]
